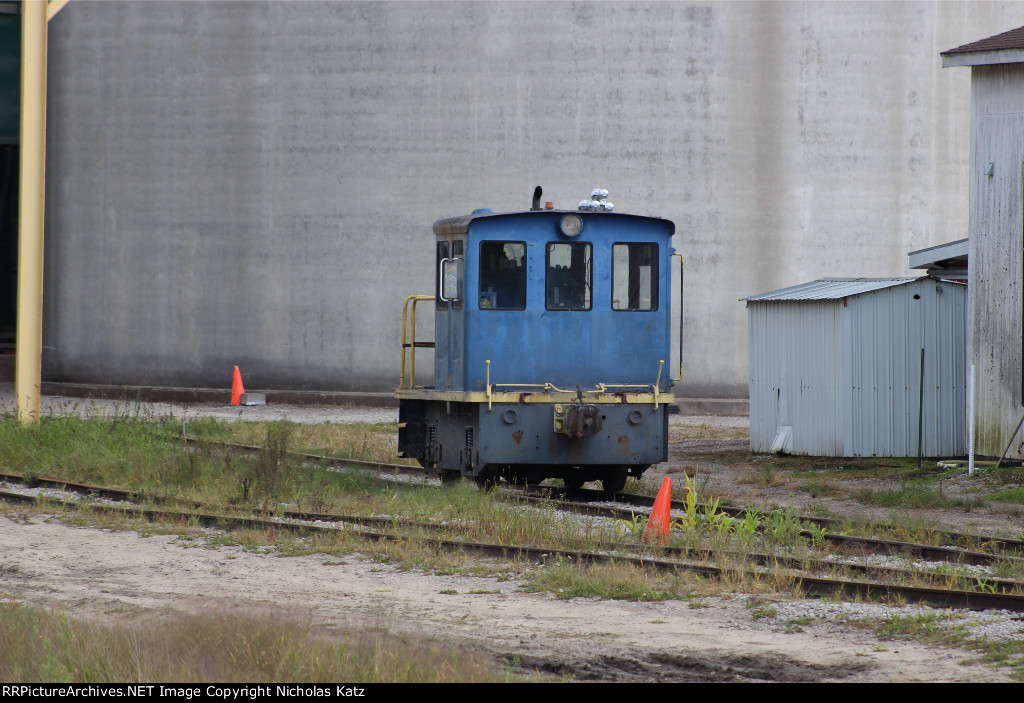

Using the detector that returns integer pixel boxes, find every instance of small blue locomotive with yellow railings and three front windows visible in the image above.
[395,187,675,491]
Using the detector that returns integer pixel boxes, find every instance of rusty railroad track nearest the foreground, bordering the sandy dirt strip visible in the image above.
[6,474,1024,612]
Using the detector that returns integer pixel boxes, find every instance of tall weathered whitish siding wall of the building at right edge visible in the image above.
[969,64,1024,458]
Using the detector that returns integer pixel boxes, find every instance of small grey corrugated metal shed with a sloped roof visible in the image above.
[744,276,967,456]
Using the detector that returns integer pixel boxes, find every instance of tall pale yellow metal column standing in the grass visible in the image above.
[14,0,47,424]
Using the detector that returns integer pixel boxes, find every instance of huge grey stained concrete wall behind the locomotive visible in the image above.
[43,0,1022,396]
